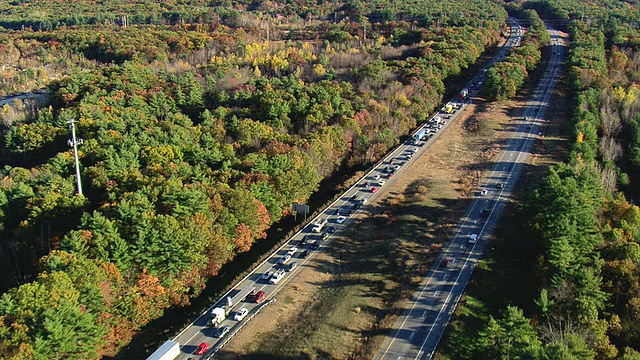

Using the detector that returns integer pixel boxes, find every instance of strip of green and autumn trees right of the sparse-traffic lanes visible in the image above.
[450,0,640,360]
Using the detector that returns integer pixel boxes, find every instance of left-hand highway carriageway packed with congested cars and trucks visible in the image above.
[154,17,521,359]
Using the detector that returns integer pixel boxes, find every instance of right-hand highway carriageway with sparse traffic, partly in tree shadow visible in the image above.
[375,23,565,360]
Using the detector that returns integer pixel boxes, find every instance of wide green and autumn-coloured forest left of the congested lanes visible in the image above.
[0,0,510,359]
